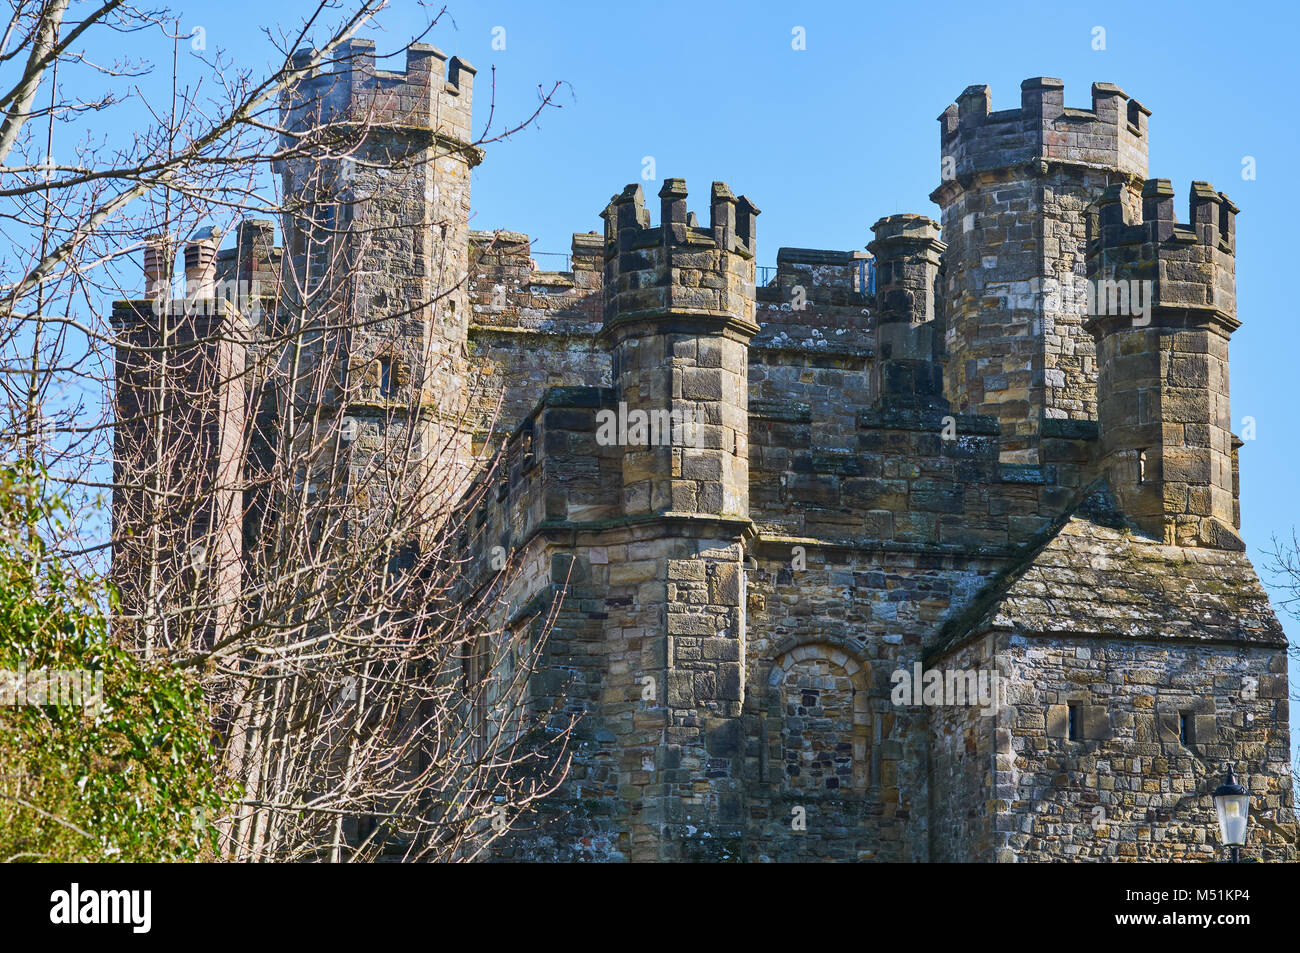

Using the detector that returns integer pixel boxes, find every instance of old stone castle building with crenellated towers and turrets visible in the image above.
[116,42,1295,862]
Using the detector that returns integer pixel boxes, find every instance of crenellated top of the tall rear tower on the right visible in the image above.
[939,77,1151,181]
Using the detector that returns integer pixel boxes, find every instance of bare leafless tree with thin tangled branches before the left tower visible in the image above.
[0,0,572,861]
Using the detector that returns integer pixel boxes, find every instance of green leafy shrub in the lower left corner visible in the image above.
[0,467,221,862]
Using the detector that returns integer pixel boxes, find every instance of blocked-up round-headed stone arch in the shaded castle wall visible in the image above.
[767,642,871,797]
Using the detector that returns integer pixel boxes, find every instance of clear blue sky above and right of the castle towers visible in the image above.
[104,0,1300,759]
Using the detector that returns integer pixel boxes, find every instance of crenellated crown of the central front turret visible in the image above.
[601,178,759,333]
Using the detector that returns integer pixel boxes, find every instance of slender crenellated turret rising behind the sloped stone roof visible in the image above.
[1088,179,1244,550]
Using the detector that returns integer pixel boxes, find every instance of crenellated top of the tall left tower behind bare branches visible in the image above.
[283,39,476,144]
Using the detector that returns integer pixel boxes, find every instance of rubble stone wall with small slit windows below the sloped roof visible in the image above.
[993,634,1295,862]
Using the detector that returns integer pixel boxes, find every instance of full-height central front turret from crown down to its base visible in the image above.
[595,178,758,859]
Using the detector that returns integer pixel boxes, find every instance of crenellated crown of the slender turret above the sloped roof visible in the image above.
[1088,178,1238,326]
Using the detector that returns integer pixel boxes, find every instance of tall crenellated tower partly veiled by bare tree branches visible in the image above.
[281,39,482,509]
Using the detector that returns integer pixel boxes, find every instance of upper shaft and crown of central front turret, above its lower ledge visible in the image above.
[603,178,758,519]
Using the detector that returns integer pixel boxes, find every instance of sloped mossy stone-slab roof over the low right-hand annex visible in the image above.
[926,482,1287,657]
